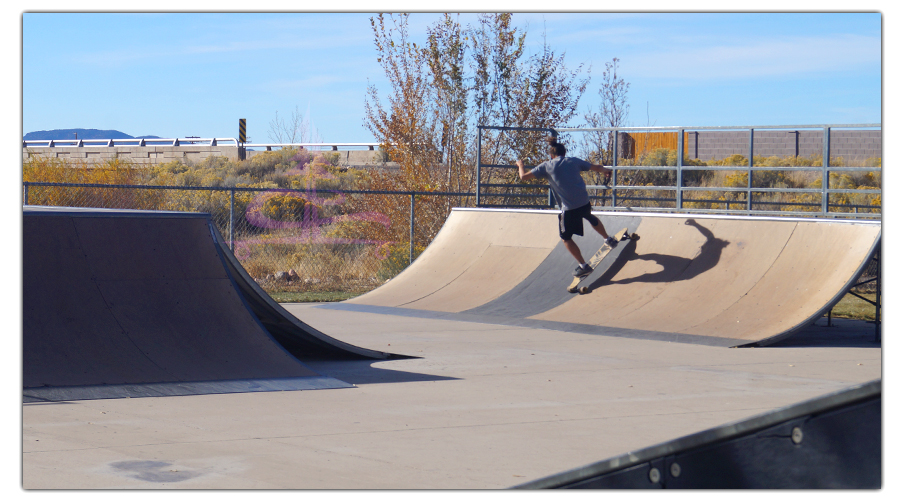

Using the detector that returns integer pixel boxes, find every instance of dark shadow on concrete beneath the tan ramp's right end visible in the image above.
[764,318,881,349]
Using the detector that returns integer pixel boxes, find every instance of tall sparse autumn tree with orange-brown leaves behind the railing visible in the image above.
[361,13,589,258]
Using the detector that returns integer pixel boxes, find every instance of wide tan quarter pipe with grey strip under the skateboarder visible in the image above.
[332,209,881,347]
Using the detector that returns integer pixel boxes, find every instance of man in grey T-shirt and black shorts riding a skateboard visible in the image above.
[516,137,617,276]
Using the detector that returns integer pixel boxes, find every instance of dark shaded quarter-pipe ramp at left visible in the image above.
[22,207,390,401]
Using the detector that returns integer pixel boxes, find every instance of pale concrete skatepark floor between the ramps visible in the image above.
[22,304,882,489]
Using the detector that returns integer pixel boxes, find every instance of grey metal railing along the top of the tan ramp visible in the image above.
[476,124,882,218]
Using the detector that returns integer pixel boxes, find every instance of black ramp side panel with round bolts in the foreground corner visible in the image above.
[519,380,882,489]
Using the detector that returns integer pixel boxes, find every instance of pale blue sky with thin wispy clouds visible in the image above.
[22,12,883,143]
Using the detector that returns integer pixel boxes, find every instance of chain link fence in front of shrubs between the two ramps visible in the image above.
[23,182,470,293]
